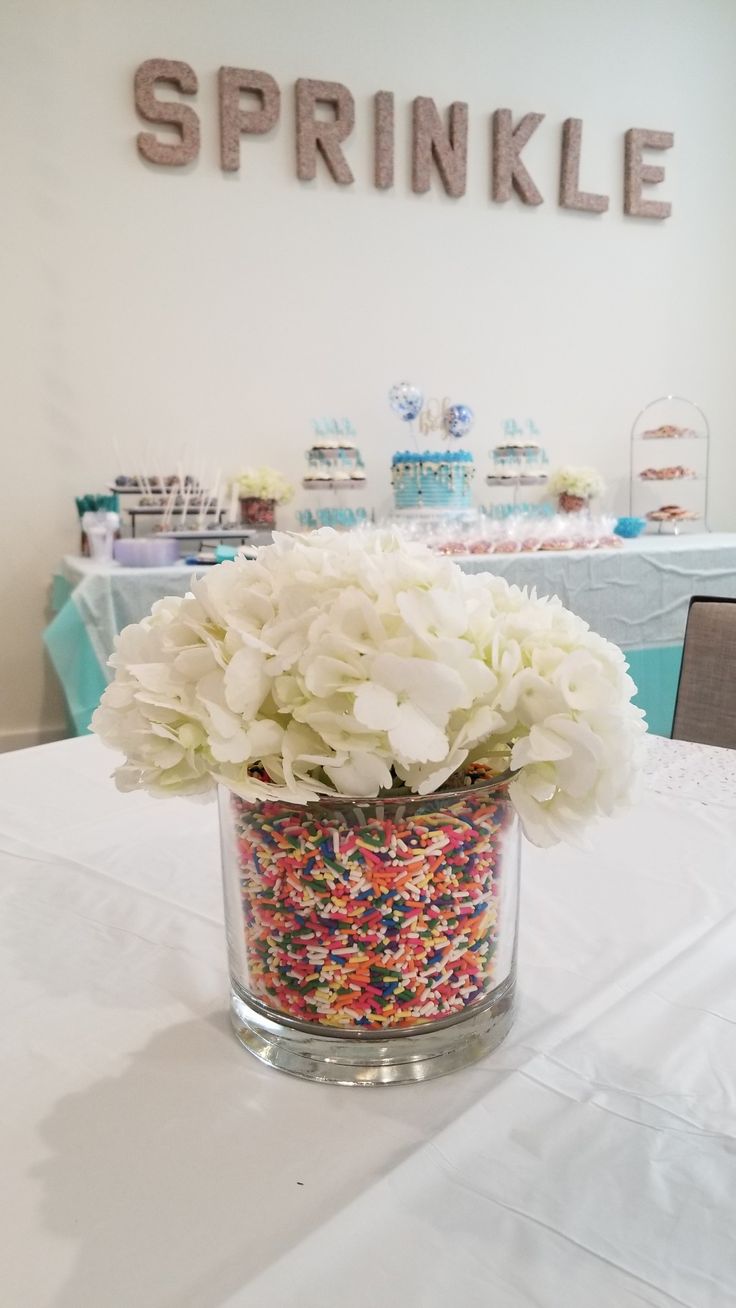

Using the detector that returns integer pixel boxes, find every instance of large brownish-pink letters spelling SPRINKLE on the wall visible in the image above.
[135,59,675,218]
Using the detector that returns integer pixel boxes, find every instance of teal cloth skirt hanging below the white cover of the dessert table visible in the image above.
[43,577,682,736]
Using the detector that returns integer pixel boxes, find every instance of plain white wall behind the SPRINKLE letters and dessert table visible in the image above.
[0,0,736,739]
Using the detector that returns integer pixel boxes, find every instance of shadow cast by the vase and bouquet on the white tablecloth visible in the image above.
[35,1012,535,1308]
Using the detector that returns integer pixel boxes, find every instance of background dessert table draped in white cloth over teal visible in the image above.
[44,532,736,735]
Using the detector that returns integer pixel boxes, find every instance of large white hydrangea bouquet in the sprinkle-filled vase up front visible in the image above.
[93,528,644,845]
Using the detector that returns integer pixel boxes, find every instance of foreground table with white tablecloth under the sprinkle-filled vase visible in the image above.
[0,738,736,1308]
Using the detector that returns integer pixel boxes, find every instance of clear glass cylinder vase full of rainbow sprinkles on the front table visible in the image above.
[220,778,520,1086]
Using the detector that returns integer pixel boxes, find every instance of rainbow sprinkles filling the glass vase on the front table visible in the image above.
[227,770,518,1031]
